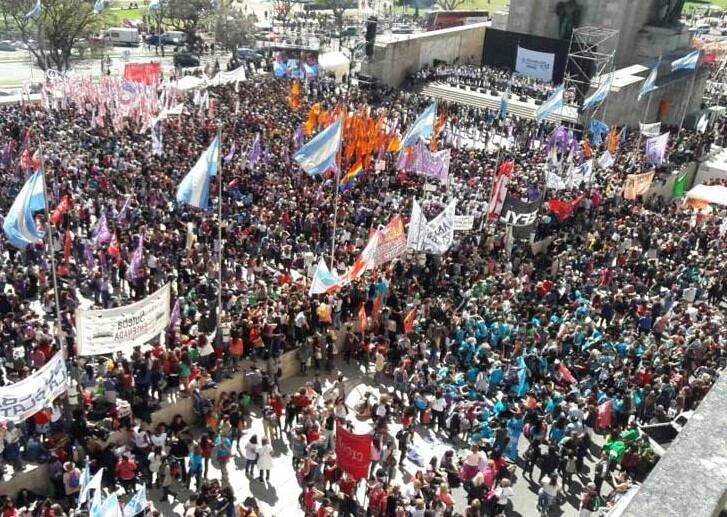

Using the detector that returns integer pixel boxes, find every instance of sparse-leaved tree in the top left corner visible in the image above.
[0,0,100,71]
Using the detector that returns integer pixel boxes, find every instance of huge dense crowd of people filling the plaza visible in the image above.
[0,48,727,517]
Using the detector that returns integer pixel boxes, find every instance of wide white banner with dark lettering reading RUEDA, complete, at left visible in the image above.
[76,284,171,355]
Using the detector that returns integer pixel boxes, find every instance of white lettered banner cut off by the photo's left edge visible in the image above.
[0,352,68,422]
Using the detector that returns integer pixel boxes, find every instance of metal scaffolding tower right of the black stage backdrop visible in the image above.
[564,27,619,116]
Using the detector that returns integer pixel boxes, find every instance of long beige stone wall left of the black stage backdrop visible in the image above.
[361,23,487,87]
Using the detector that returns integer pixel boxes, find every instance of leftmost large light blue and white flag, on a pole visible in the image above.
[3,167,45,249]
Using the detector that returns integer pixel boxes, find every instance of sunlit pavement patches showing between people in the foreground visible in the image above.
[119,363,593,517]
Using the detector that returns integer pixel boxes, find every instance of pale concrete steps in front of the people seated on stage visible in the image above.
[422,82,578,123]
